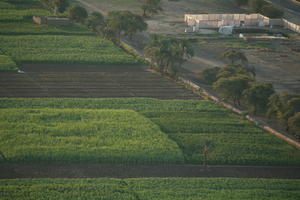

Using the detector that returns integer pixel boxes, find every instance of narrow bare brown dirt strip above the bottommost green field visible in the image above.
[0,163,300,179]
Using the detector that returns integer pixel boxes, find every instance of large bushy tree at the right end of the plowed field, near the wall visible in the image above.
[145,35,194,76]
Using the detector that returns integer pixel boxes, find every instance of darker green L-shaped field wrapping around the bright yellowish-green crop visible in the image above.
[0,98,300,166]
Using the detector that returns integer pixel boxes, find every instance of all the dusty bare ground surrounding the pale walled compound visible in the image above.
[80,0,300,93]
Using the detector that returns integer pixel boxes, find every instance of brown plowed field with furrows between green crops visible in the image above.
[0,65,199,99]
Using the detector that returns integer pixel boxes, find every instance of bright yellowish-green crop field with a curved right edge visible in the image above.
[0,109,184,163]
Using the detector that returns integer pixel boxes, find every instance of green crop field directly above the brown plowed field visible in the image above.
[0,35,139,64]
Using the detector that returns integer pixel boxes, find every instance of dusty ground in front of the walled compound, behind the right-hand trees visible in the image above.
[184,39,300,93]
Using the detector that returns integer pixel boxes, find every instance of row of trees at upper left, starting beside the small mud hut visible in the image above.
[43,0,148,43]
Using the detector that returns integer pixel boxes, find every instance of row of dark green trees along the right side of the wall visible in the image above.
[200,50,300,137]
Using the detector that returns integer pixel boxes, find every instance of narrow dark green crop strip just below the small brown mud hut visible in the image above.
[0,22,95,35]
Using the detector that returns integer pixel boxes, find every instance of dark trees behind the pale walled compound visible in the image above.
[234,0,283,18]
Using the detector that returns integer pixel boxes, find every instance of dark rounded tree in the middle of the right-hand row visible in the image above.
[243,82,275,114]
